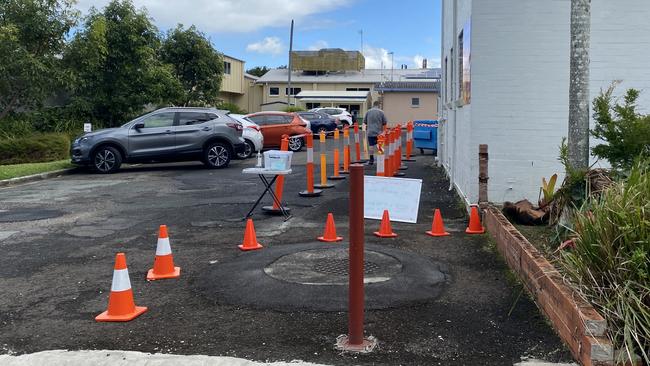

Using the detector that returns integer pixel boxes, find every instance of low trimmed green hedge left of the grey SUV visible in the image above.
[0,133,70,165]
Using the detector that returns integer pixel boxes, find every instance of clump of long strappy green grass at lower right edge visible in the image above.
[560,160,650,363]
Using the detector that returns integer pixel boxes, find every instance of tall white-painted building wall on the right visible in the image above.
[438,0,650,203]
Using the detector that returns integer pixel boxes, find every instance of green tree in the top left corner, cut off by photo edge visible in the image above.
[0,0,78,119]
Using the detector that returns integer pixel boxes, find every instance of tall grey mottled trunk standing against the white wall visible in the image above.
[568,0,591,170]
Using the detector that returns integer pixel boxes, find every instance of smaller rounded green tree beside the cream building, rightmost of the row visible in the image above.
[160,24,223,105]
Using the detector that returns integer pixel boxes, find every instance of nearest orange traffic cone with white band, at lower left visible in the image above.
[95,253,147,322]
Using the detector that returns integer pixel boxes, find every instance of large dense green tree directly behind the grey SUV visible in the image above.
[64,0,182,127]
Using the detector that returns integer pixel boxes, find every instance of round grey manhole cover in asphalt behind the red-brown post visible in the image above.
[264,248,402,285]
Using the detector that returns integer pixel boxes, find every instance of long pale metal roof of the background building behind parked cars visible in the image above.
[257,69,440,84]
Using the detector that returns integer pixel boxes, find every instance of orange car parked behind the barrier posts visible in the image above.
[246,112,310,151]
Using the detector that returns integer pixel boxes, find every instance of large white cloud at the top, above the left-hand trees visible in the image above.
[77,0,354,33]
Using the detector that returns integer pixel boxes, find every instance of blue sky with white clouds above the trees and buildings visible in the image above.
[78,0,440,68]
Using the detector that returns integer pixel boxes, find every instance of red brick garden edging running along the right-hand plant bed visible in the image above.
[484,207,614,366]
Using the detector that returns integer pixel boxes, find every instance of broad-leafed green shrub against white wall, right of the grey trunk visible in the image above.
[591,85,650,171]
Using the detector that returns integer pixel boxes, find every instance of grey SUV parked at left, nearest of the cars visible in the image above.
[70,108,246,173]
